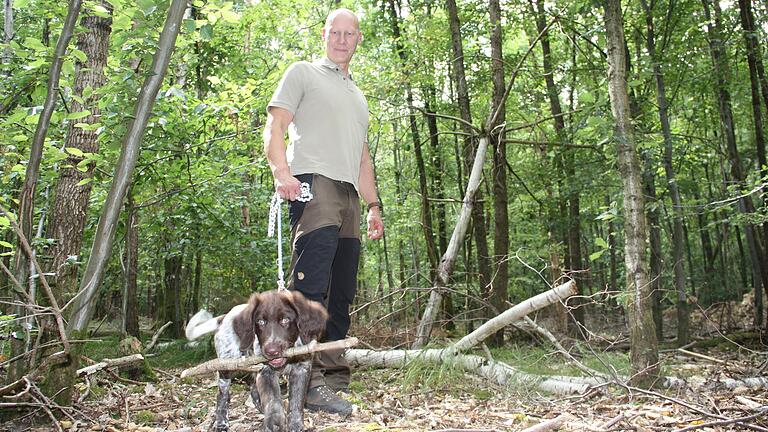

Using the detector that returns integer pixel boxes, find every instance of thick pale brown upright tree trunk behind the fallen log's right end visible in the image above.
[604,0,659,386]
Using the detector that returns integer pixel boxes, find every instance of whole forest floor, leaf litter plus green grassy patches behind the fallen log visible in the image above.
[0,296,768,432]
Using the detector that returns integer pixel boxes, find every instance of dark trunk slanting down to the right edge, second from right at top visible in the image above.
[702,0,768,326]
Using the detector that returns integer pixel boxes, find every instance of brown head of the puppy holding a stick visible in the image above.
[234,291,328,368]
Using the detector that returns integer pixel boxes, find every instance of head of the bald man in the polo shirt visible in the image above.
[323,8,363,71]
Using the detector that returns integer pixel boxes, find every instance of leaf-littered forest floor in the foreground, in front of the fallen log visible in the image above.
[0,334,768,432]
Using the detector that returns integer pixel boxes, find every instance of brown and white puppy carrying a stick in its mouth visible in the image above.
[186,291,328,432]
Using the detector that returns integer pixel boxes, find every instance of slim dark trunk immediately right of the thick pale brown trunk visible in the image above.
[641,0,690,346]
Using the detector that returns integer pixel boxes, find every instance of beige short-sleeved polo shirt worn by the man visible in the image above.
[267,57,368,189]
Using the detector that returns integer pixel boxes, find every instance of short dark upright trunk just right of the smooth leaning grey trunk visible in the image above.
[122,188,140,338]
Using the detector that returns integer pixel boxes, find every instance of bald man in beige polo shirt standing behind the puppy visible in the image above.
[264,9,384,415]
